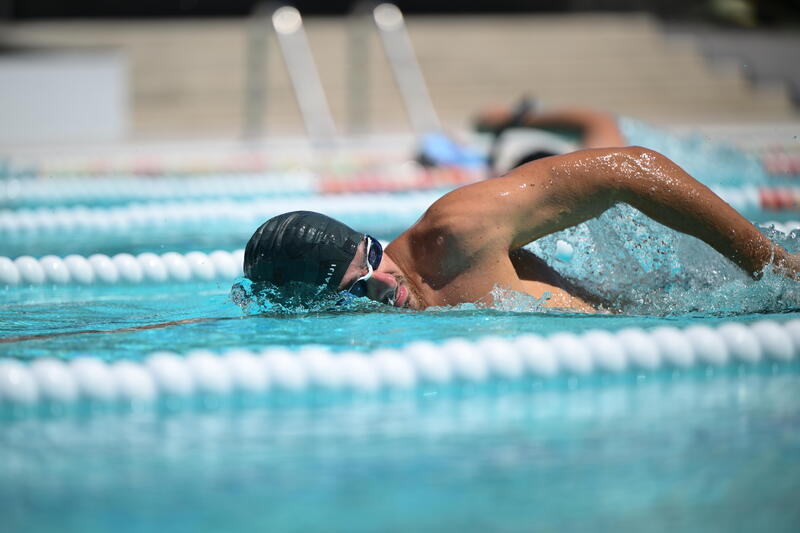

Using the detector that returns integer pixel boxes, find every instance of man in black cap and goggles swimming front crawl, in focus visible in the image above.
[244,146,800,313]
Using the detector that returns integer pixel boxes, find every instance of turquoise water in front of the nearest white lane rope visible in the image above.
[0,368,800,532]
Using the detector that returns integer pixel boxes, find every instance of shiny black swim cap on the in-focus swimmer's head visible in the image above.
[244,211,364,290]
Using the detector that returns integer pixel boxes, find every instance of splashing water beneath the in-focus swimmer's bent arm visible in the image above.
[530,205,800,316]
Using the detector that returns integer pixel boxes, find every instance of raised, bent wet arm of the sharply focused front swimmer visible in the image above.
[432,147,800,277]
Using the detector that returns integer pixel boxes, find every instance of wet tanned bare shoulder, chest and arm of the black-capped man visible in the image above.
[379,147,800,312]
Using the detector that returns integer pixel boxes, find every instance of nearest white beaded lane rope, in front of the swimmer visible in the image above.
[0,320,800,408]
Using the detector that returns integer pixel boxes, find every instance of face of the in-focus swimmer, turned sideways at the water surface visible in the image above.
[338,239,421,309]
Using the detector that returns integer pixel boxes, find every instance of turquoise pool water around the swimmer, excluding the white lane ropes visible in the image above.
[0,125,800,532]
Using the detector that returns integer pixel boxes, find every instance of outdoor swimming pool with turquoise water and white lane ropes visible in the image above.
[0,127,800,531]
